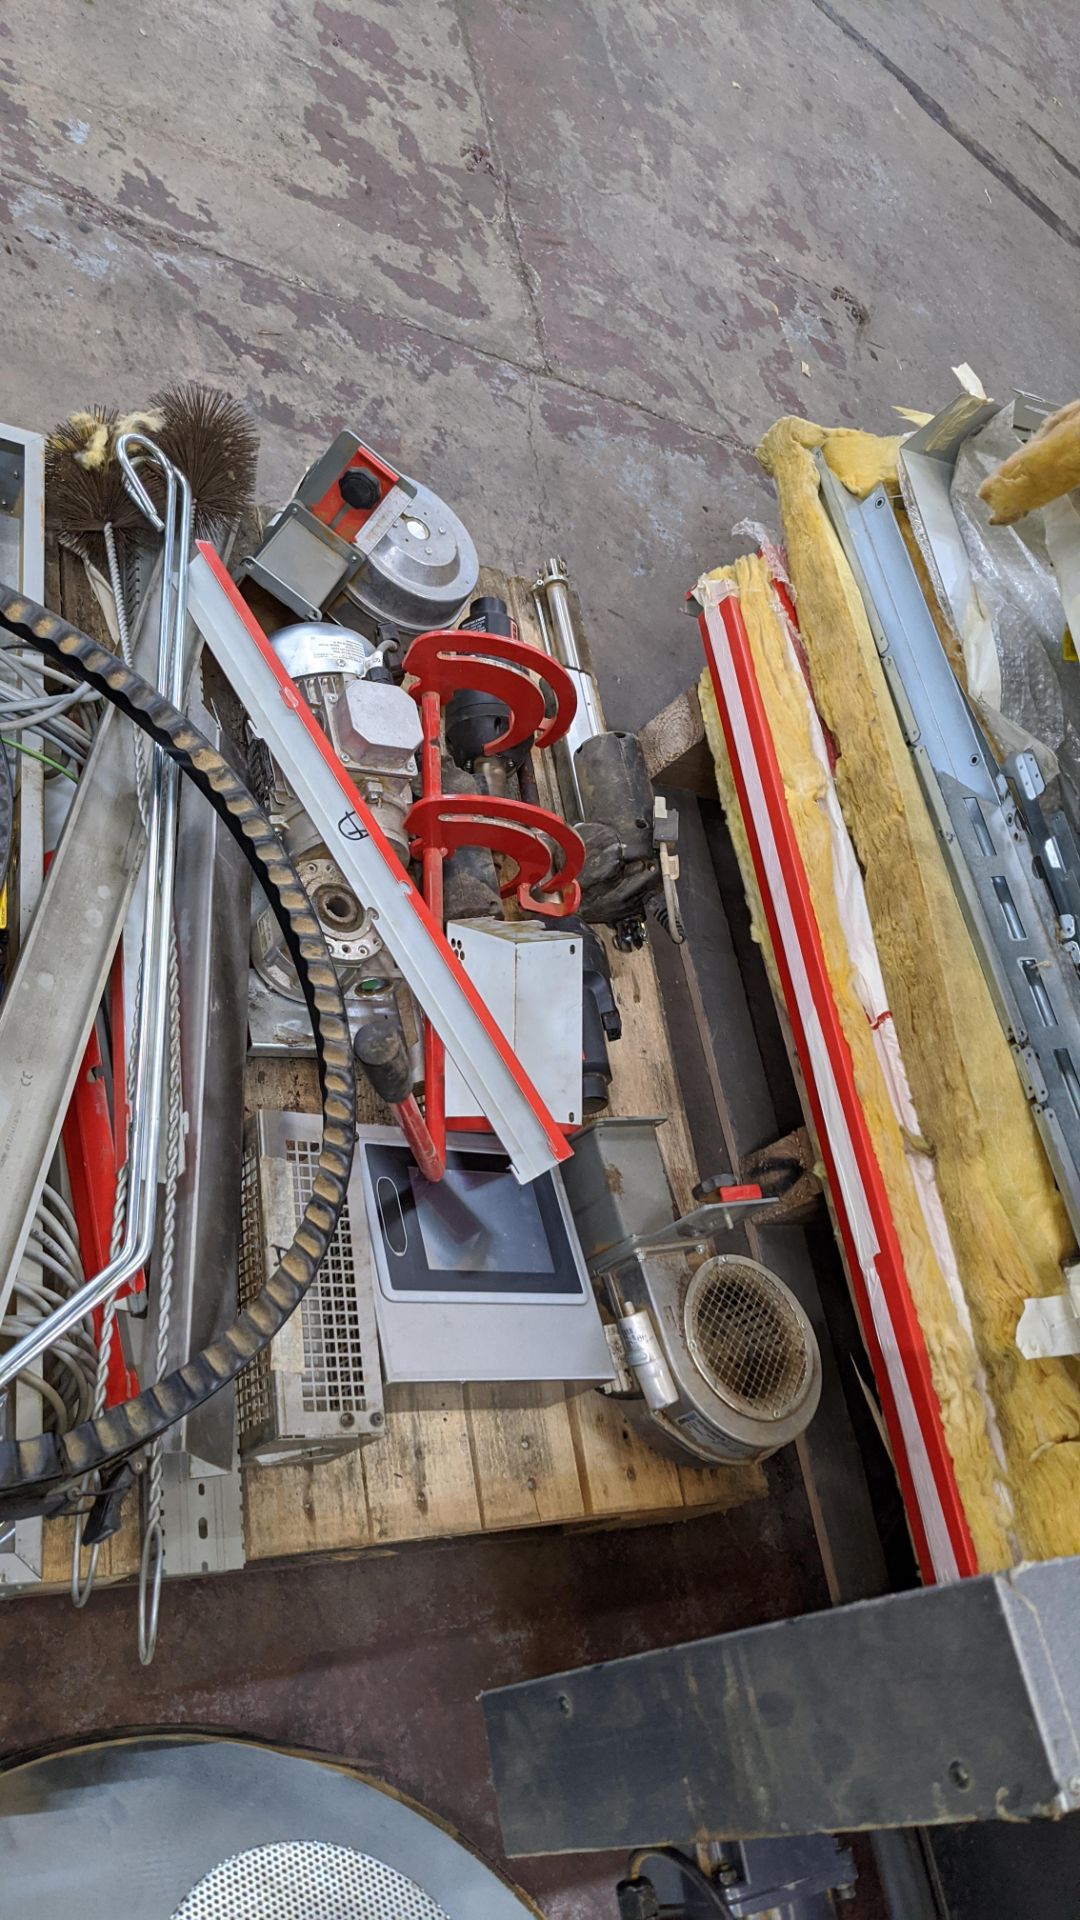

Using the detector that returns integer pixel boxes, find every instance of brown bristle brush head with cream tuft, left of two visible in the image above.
[44,407,146,566]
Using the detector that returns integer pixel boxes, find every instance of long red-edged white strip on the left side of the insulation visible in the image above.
[698,582,978,1580]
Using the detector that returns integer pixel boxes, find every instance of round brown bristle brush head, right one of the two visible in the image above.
[148,380,259,540]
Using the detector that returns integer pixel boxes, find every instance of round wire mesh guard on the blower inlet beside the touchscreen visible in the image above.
[682,1258,811,1421]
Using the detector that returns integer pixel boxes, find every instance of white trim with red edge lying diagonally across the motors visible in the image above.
[188,541,571,1181]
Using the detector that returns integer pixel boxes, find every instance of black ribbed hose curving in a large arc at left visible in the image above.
[0,586,356,1521]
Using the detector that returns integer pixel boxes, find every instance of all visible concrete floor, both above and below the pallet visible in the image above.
[0,0,1080,1920]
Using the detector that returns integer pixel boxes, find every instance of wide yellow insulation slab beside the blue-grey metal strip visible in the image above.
[759,419,1080,1567]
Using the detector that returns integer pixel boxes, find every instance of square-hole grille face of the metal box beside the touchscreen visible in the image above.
[284,1137,367,1413]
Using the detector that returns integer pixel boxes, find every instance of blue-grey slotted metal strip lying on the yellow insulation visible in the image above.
[821,463,1080,1238]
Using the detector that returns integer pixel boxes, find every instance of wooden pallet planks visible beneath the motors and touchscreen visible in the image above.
[44,570,765,1586]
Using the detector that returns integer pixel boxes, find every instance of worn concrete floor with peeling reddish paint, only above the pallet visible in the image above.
[0,0,1080,726]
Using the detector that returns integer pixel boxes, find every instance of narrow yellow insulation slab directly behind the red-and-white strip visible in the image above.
[703,556,1019,1569]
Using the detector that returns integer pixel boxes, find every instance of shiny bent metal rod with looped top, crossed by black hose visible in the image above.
[0,434,192,1390]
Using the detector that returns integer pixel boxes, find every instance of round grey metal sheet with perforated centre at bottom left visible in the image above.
[0,1734,536,1920]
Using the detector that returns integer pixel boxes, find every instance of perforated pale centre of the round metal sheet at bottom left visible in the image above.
[173,1839,448,1920]
